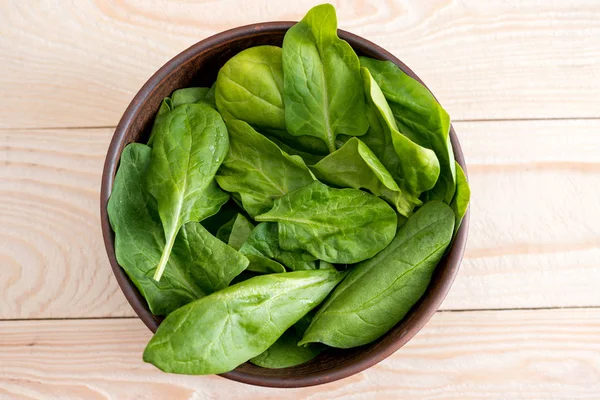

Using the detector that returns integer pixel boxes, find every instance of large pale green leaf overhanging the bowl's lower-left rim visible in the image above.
[144,270,344,375]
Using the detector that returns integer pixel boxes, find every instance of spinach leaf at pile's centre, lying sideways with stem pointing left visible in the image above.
[255,181,397,264]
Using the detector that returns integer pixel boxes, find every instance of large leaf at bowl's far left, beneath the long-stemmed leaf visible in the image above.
[107,143,248,315]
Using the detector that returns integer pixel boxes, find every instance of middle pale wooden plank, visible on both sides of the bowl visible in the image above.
[0,120,600,319]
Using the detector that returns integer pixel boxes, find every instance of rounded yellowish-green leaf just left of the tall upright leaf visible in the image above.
[215,46,285,130]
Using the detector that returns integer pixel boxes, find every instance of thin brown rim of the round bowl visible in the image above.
[100,21,470,388]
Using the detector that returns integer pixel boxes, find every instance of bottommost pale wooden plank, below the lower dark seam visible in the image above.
[0,309,600,399]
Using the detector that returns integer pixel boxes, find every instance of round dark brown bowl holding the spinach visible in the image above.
[100,22,469,387]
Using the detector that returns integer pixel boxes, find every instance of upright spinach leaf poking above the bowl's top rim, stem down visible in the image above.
[283,4,368,152]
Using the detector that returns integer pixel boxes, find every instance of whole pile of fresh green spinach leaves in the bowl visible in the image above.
[108,4,470,374]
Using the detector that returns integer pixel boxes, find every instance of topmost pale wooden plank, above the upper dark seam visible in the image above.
[0,0,600,128]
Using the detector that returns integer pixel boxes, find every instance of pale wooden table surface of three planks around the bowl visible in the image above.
[0,0,600,399]
